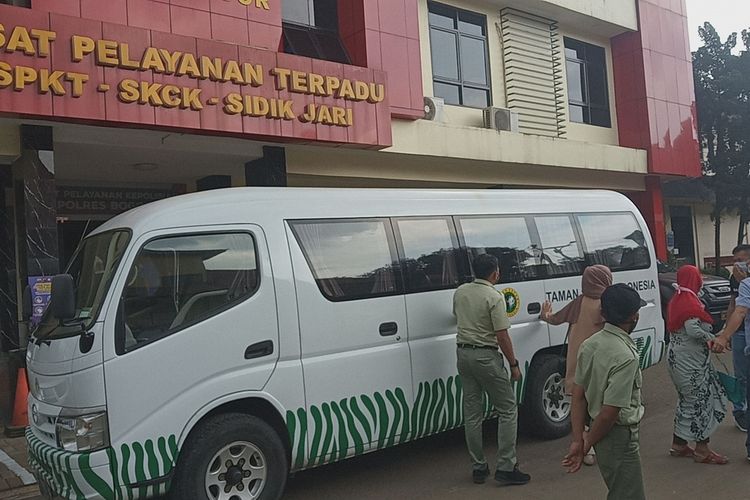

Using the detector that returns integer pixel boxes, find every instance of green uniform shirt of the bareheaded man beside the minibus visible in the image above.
[453,279,510,347]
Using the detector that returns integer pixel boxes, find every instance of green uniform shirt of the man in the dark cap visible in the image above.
[576,323,644,425]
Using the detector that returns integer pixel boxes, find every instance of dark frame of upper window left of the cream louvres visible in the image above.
[427,0,493,109]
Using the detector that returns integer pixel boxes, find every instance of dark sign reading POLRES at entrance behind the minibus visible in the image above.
[57,186,175,217]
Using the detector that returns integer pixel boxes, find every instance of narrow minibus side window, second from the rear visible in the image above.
[534,215,584,278]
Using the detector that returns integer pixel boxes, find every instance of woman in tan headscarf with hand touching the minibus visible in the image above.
[541,266,612,465]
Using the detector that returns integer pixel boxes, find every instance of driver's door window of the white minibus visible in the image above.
[120,233,259,351]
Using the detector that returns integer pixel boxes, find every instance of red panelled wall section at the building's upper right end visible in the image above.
[612,0,701,177]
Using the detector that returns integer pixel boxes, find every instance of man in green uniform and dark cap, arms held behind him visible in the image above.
[563,284,646,500]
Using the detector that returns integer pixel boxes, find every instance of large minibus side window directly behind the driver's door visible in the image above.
[290,219,402,302]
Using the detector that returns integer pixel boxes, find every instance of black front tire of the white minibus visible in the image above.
[168,413,289,500]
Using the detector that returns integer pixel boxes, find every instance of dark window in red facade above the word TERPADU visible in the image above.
[281,0,350,64]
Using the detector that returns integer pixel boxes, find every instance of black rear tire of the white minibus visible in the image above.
[521,354,570,439]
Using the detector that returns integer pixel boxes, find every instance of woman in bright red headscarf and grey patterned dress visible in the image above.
[667,266,728,465]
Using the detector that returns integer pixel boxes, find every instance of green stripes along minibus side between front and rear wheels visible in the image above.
[286,362,529,470]
